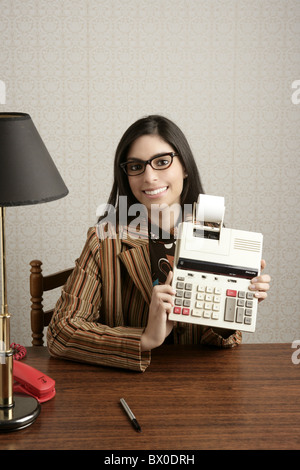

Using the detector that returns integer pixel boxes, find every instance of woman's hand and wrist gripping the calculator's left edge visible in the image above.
[141,271,176,351]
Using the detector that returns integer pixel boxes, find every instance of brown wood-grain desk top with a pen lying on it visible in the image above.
[0,344,300,451]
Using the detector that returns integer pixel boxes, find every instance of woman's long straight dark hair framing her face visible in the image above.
[101,115,204,227]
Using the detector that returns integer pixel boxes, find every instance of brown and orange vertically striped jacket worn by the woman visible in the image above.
[47,224,241,371]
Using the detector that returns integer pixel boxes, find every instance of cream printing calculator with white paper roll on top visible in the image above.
[169,194,263,332]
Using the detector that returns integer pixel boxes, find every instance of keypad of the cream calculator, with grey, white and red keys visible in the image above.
[173,276,253,325]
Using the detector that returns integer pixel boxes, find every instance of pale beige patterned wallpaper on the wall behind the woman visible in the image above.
[0,0,300,345]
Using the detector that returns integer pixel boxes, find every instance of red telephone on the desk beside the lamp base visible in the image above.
[13,360,56,403]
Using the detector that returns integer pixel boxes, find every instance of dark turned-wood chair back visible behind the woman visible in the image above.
[30,260,73,346]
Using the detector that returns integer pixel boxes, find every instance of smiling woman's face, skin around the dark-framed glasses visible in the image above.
[127,135,185,219]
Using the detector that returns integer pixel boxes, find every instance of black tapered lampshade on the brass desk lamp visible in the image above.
[0,113,69,207]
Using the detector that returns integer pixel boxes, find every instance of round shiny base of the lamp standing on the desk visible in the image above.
[0,395,41,433]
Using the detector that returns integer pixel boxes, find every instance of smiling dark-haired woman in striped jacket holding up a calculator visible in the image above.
[47,116,270,371]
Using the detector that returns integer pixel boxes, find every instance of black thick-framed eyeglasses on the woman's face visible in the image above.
[120,152,178,176]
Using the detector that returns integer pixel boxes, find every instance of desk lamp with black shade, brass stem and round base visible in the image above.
[0,113,68,432]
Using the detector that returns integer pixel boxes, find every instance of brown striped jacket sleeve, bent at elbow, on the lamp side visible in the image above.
[47,228,150,372]
